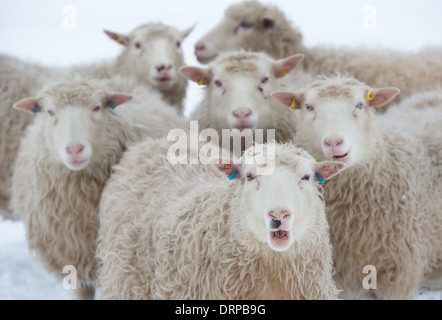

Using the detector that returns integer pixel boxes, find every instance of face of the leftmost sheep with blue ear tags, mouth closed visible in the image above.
[14,83,131,171]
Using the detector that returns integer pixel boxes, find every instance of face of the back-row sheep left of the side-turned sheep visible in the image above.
[105,24,193,91]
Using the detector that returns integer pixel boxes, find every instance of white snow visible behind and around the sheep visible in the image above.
[0,0,442,300]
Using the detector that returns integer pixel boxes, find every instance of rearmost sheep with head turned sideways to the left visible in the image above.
[195,1,442,112]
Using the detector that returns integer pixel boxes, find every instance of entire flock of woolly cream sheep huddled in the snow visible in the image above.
[0,0,442,300]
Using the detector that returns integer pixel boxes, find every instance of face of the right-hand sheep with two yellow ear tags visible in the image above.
[273,77,399,166]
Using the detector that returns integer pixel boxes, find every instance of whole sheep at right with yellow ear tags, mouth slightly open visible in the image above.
[272,75,442,299]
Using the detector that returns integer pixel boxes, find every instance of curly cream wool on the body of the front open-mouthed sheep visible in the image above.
[97,141,337,299]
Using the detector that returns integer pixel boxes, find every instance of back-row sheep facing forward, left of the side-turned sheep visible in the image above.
[78,23,193,113]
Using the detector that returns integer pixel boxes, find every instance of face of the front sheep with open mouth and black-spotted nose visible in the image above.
[218,145,344,252]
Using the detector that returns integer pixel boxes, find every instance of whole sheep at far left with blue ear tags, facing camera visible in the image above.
[11,75,185,299]
